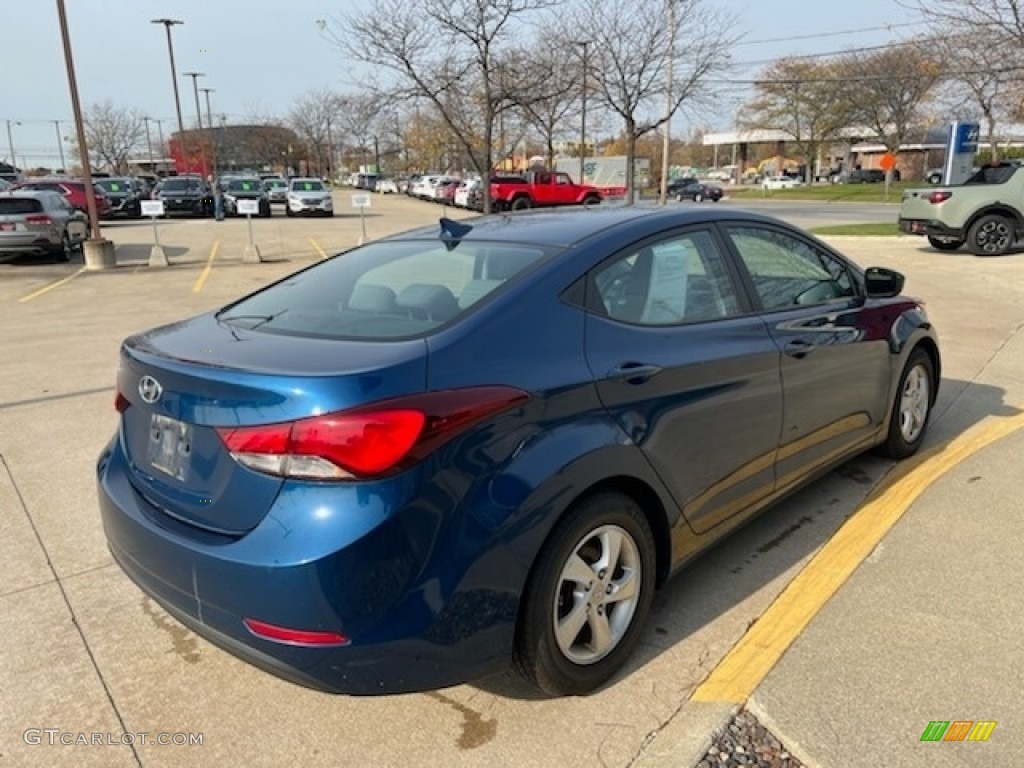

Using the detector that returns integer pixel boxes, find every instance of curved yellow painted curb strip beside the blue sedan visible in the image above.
[691,413,1024,705]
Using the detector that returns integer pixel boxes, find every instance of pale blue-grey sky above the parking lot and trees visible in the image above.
[6,0,920,167]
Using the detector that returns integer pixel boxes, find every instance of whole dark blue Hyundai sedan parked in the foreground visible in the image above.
[97,208,940,695]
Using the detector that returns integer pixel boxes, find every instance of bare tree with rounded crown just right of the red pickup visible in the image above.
[571,0,736,200]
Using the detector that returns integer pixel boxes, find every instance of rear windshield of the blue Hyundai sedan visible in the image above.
[218,241,554,340]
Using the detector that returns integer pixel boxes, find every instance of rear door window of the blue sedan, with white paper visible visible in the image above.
[594,230,740,326]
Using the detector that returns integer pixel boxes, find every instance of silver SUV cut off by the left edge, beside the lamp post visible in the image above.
[0,190,89,261]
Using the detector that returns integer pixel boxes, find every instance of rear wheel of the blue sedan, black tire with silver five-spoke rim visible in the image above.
[515,493,656,695]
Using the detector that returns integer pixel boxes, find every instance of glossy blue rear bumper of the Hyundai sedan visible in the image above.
[97,438,525,694]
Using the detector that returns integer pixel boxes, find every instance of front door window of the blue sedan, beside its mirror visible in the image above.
[726,226,857,311]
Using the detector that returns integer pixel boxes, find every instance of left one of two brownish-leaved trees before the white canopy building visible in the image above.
[740,57,849,183]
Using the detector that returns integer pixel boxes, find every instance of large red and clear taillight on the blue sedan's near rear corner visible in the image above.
[210,387,529,480]
